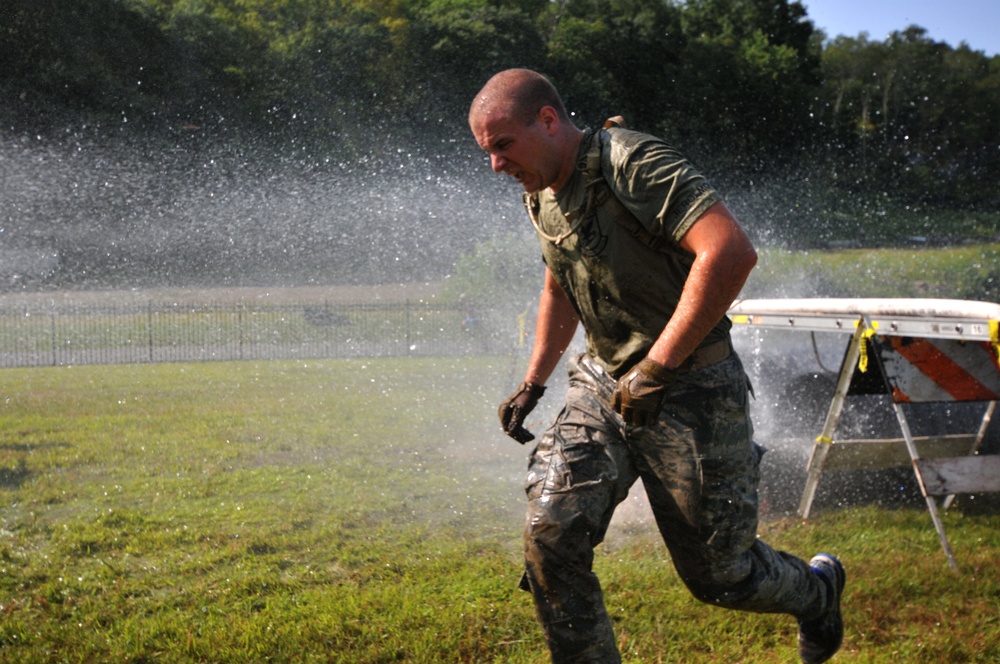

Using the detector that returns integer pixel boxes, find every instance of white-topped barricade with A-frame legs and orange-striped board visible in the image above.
[729,298,1000,569]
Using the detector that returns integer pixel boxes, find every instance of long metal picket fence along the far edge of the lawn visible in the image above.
[0,301,508,367]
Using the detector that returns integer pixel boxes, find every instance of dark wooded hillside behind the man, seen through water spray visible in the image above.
[0,0,1000,287]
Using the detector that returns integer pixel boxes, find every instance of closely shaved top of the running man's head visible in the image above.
[469,69,568,125]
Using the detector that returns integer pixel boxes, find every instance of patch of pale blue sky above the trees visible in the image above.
[799,0,1000,55]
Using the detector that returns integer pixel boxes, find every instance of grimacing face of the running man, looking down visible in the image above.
[469,106,559,193]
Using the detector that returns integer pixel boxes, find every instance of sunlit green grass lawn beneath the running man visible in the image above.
[0,358,1000,664]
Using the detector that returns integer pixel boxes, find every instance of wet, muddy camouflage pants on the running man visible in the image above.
[522,354,826,663]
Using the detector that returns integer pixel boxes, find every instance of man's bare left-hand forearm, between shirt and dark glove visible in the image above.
[524,268,580,385]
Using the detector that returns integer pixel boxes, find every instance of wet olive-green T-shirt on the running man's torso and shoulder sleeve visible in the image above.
[536,128,731,376]
